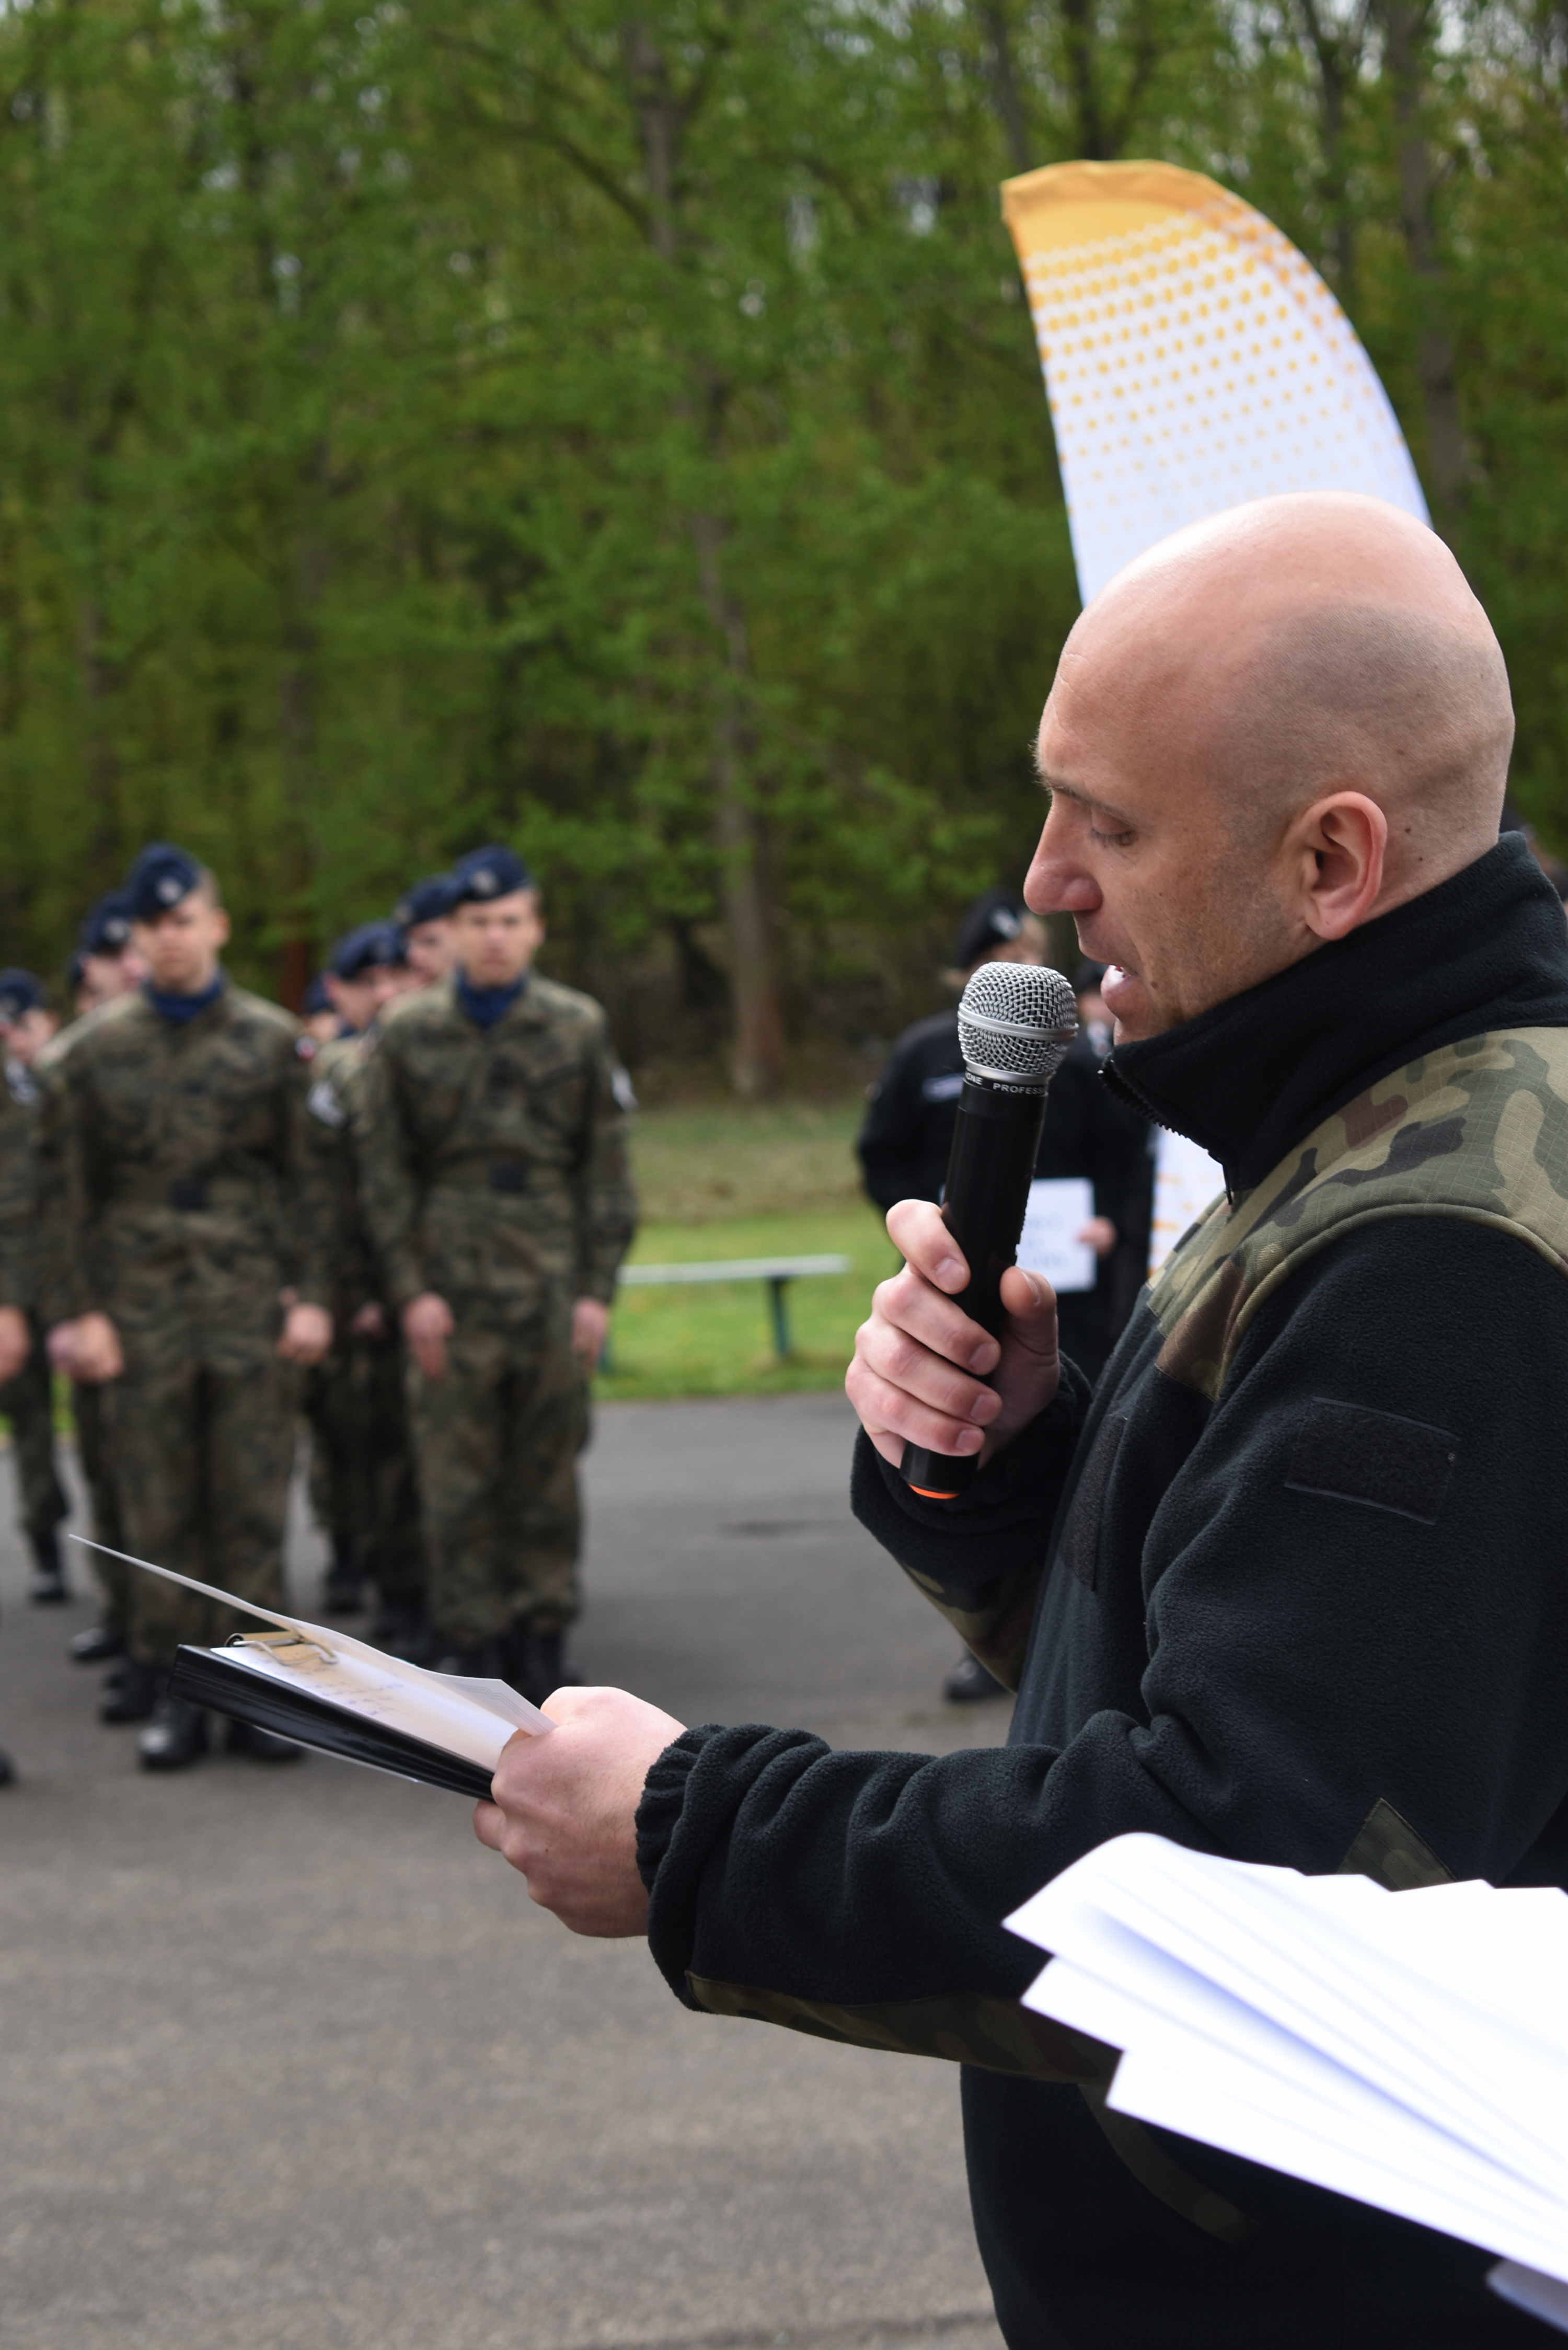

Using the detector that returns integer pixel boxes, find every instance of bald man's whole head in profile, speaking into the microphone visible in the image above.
[1028,491,1514,1034]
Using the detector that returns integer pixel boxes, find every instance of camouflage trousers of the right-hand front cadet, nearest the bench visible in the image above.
[409,1299,587,1648]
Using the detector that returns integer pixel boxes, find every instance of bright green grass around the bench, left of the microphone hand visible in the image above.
[595,1201,898,1398]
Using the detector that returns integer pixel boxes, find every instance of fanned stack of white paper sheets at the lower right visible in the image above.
[1006,1835,1568,2331]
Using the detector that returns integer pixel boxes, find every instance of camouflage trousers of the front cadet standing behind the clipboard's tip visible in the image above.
[103,1344,296,1668]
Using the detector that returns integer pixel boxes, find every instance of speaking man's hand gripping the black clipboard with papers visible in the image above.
[472,1690,686,1937]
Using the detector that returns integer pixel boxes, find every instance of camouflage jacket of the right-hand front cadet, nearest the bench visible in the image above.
[355,973,637,1321]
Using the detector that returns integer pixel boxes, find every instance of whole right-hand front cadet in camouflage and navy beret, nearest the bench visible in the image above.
[360,848,635,1697]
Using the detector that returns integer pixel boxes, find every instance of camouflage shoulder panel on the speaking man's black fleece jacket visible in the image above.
[1149,1027,1568,1398]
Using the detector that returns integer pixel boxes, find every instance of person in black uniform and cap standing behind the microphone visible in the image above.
[856,888,1147,1704]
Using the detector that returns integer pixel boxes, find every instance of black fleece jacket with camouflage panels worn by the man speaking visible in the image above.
[639,842,1568,2350]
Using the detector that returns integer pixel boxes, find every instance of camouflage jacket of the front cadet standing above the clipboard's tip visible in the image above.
[38,980,339,1346]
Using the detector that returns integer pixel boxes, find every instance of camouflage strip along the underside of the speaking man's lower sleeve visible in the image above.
[686,1974,1119,2084]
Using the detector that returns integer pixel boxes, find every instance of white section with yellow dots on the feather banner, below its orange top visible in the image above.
[1016,190,1427,602]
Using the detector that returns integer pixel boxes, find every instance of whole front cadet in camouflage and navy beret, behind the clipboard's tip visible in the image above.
[44,844,334,1769]
